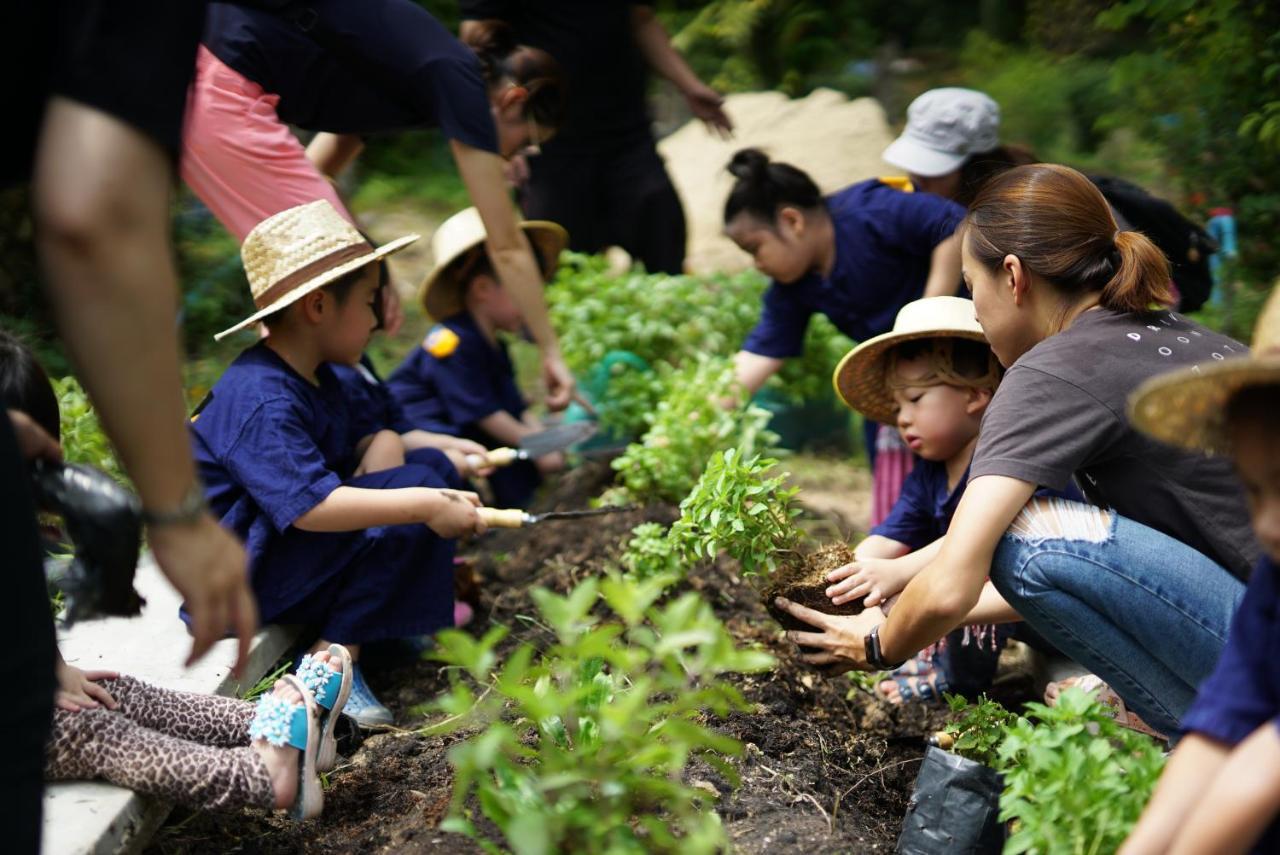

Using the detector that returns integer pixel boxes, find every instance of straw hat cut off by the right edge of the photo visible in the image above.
[1129,287,1280,454]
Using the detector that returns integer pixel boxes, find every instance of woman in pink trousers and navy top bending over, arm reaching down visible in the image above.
[182,0,573,407]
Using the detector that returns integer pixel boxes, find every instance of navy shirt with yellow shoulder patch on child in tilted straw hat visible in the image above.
[387,312,525,443]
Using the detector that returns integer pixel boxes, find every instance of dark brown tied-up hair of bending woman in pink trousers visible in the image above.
[463,20,564,128]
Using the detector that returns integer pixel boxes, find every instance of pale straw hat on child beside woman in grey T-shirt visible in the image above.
[831,297,987,424]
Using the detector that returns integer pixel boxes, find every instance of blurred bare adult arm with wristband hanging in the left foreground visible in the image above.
[35,97,257,672]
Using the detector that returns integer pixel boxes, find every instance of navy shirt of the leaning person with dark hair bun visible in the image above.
[742,179,964,360]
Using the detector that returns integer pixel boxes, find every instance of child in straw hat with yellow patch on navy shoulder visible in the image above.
[387,207,568,507]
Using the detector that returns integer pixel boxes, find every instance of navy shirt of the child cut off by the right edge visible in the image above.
[1181,558,1280,852]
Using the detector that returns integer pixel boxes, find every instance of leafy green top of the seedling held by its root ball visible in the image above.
[671,448,801,576]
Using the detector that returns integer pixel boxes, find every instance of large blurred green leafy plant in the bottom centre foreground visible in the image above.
[429,576,773,855]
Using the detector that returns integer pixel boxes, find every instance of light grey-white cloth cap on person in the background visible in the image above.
[881,87,1000,178]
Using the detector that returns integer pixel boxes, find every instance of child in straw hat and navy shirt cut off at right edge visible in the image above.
[1121,289,1280,855]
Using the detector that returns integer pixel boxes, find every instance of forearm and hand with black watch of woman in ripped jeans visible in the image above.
[778,475,1036,671]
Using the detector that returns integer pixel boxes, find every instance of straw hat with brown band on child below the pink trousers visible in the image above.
[214,198,419,339]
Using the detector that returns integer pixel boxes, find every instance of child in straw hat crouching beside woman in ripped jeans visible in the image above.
[827,297,1075,703]
